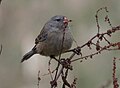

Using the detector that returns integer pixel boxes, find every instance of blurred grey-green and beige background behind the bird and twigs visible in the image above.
[0,0,120,88]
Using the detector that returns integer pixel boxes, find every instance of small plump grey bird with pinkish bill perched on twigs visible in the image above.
[21,15,73,62]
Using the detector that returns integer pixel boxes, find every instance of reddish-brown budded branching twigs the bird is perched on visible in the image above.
[37,7,120,88]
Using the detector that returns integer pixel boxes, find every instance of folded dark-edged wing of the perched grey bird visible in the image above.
[35,26,49,44]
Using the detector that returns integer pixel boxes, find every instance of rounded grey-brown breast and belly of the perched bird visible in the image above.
[36,31,73,56]
